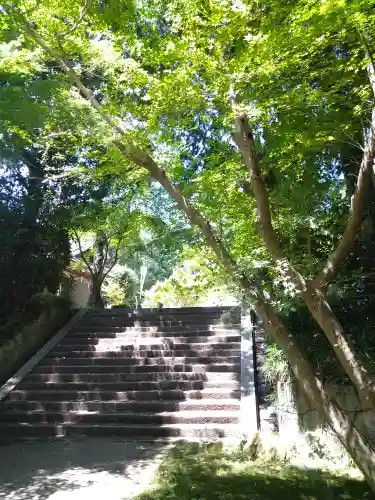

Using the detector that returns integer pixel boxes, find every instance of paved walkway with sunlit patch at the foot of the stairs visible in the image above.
[0,438,164,500]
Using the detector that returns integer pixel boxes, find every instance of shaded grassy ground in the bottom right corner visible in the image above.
[137,444,375,500]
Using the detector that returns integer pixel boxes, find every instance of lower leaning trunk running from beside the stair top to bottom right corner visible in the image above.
[255,299,375,492]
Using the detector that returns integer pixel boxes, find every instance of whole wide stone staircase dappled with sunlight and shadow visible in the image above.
[0,308,241,440]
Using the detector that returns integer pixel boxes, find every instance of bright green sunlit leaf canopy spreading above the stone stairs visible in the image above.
[4,0,374,292]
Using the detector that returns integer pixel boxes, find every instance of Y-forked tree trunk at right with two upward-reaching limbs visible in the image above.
[233,112,375,407]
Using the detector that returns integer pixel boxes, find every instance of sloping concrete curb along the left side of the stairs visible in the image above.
[0,308,88,401]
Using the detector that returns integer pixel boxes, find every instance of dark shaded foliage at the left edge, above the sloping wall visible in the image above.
[0,146,70,332]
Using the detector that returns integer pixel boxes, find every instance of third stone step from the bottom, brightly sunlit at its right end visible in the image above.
[3,398,240,413]
